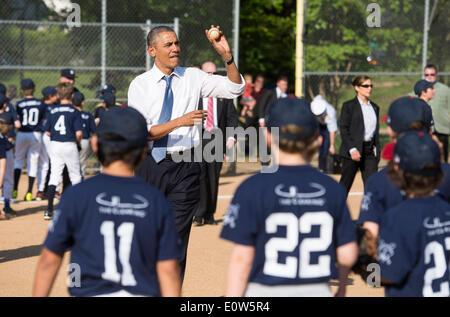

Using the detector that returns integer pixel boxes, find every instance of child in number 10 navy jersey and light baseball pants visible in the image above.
[13,79,46,201]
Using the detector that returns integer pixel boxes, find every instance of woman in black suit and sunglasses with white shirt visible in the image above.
[339,75,380,193]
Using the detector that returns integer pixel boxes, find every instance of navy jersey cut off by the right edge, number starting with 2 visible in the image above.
[377,195,450,297]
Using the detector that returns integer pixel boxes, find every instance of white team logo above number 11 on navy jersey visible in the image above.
[95,193,149,218]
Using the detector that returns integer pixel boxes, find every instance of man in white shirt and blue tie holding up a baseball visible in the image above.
[128,26,245,278]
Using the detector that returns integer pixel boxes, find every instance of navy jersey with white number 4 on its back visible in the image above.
[45,104,83,142]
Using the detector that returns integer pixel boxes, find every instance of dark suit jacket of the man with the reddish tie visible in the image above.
[198,98,238,152]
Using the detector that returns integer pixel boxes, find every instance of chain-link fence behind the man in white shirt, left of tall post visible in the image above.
[0,0,235,112]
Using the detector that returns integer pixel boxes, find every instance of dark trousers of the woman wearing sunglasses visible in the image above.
[339,142,378,194]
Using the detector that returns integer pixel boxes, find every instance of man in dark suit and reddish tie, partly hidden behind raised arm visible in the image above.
[193,62,238,225]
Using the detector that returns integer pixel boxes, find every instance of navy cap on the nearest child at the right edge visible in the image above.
[394,131,441,176]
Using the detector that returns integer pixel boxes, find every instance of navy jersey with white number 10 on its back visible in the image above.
[16,98,46,132]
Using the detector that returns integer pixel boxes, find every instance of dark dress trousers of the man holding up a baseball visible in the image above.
[136,155,200,281]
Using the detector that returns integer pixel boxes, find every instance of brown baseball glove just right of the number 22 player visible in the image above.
[352,224,377,281]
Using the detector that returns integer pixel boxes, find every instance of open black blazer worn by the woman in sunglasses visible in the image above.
[339,97,381,161]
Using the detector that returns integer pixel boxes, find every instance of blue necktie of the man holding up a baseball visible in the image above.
[152,74,173,163]
